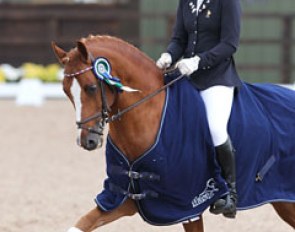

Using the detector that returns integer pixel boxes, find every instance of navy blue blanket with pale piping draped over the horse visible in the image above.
[95,75,295,225]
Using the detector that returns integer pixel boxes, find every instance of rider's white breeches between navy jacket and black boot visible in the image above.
[200,85,234,147]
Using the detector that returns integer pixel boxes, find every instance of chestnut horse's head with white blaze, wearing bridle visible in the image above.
[52,39,116,150]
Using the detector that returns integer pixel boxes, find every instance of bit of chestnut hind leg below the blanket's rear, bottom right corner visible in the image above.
[272,202,295,229]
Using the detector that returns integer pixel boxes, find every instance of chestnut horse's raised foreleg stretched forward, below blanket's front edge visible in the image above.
[69,200,137,232]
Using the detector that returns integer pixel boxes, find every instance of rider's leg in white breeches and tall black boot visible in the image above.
[200,86,237,218]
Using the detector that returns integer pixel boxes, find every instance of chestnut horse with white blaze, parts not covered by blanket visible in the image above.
[52,36,295,232]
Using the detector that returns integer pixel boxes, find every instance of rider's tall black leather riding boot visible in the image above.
[210,139,237,218]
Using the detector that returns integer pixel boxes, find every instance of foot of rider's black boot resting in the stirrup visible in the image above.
[209,194,237,218]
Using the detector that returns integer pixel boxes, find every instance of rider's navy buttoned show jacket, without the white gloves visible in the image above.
[167,0,241,90]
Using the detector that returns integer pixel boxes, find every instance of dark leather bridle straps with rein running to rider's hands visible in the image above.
[64,54,185,135]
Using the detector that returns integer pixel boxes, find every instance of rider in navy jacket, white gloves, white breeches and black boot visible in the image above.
[157,0,241,218]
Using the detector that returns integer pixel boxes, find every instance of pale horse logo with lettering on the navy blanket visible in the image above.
[192,178,219,208]
